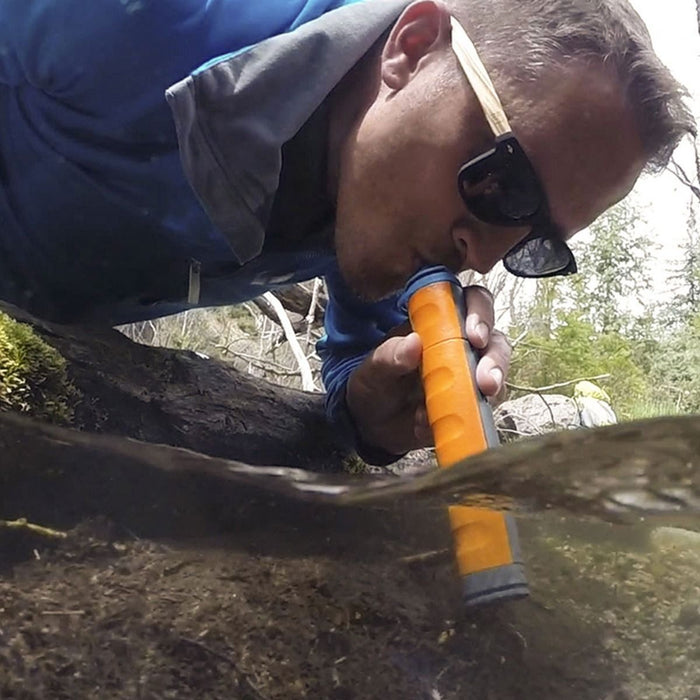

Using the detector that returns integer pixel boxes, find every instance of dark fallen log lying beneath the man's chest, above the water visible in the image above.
[0,304,346,471]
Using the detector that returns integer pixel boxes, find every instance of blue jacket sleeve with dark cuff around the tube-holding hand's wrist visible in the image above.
[317,265,407,464]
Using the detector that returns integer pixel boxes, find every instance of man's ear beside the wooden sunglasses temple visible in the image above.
[381,0,452,90]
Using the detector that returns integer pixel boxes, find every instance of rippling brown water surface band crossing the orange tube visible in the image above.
[15,414,700,521]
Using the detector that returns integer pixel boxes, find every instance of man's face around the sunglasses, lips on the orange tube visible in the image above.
[336,44,644,300]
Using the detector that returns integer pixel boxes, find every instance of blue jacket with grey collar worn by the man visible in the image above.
[0,0,408,452]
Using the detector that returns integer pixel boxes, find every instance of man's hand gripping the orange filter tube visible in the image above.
[346,286,511,455]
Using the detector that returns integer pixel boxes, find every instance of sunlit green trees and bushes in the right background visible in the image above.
[509,194,700,419]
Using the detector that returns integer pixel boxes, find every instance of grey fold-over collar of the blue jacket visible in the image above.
[166,0,409,264]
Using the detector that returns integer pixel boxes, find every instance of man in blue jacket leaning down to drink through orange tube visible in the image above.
[0,0,694,462]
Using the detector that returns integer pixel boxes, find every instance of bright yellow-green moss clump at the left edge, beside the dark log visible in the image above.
[0,312,80,423]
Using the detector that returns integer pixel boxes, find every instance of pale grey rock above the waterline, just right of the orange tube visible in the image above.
[494,394,581,442]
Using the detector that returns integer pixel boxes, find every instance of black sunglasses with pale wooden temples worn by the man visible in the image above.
[451,17,577,277]
